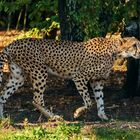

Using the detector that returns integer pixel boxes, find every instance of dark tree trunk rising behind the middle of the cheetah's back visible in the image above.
[58,0,83,41]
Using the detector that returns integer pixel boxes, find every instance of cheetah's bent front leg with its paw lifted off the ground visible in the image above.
[73,76,92,118]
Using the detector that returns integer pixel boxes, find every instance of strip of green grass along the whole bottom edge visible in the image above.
[0,119,140,140]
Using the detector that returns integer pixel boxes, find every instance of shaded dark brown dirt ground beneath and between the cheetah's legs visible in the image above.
[1,72,140,123]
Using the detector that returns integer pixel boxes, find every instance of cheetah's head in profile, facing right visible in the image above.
[118,37,140,59]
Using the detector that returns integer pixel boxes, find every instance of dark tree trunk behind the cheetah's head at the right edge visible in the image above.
[126,0,140,97]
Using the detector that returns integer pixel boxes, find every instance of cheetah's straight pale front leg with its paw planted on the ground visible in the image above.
[90,81,108,120]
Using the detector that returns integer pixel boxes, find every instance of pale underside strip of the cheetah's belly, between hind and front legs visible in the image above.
[47,67,72,79]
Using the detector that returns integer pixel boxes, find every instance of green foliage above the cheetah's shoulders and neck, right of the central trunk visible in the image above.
[66,0,138,40]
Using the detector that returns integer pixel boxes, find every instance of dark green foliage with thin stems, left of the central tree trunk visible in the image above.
[0,0,59,32]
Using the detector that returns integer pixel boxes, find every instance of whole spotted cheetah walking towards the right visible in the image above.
[0,37,140,120]
